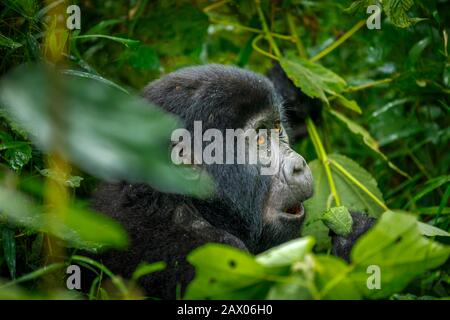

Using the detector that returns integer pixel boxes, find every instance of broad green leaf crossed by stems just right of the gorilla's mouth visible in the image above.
[302,154,384,250]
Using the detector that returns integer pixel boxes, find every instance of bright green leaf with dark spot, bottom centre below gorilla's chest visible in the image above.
[185,243,270,299]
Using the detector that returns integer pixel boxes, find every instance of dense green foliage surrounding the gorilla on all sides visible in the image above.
[0,0,450,299]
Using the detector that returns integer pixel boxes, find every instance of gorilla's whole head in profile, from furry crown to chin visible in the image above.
[144,65,313,253]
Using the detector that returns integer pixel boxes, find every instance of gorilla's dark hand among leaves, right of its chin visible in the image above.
[330,212,376,262]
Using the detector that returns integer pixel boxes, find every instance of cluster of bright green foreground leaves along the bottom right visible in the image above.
[186,211,450,299]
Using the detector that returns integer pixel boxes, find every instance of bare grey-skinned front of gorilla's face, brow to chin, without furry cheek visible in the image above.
[229,110,313,253]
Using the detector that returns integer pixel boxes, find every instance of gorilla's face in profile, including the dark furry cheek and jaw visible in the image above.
[199,106,313,253]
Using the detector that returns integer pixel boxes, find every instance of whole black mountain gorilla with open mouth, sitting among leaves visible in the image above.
[92,65,370,299]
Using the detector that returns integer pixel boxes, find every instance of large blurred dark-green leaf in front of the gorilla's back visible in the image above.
[0,66,212,196]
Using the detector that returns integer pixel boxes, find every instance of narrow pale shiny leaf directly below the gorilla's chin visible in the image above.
[256,237,314,267]
